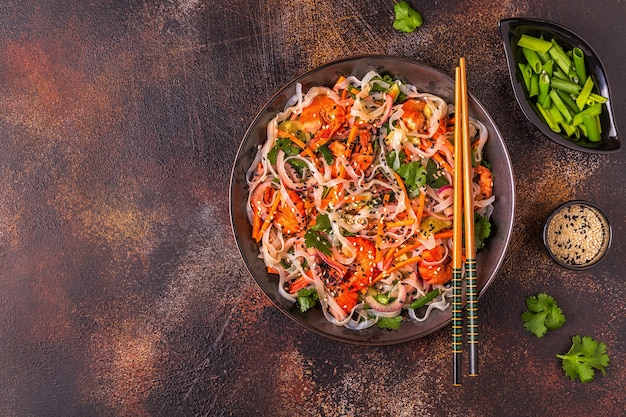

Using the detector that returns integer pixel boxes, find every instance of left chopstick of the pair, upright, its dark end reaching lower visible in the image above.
[452,67,463,386]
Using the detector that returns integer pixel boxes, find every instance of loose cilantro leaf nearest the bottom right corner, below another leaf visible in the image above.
[556,335,610,383]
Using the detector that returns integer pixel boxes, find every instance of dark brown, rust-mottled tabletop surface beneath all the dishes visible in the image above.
[0,0,626,417]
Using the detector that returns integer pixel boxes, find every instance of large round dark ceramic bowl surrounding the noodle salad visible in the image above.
[230,56,515,345]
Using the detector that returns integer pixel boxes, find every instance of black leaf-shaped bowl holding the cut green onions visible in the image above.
[499,18,620,153]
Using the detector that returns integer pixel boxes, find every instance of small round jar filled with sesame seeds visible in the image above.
[543,201,611,269]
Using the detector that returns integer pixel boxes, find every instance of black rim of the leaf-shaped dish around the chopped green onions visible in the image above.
[498,17,621,154]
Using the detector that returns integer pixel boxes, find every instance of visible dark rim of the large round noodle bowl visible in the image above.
[229,54,515,345]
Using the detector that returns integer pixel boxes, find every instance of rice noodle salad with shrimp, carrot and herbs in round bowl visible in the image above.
[246,72,495,330]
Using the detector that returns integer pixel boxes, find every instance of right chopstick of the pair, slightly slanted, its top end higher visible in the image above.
[459,58,478,376]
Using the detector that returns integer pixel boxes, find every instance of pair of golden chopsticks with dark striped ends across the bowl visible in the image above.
[452,58,478,385]
